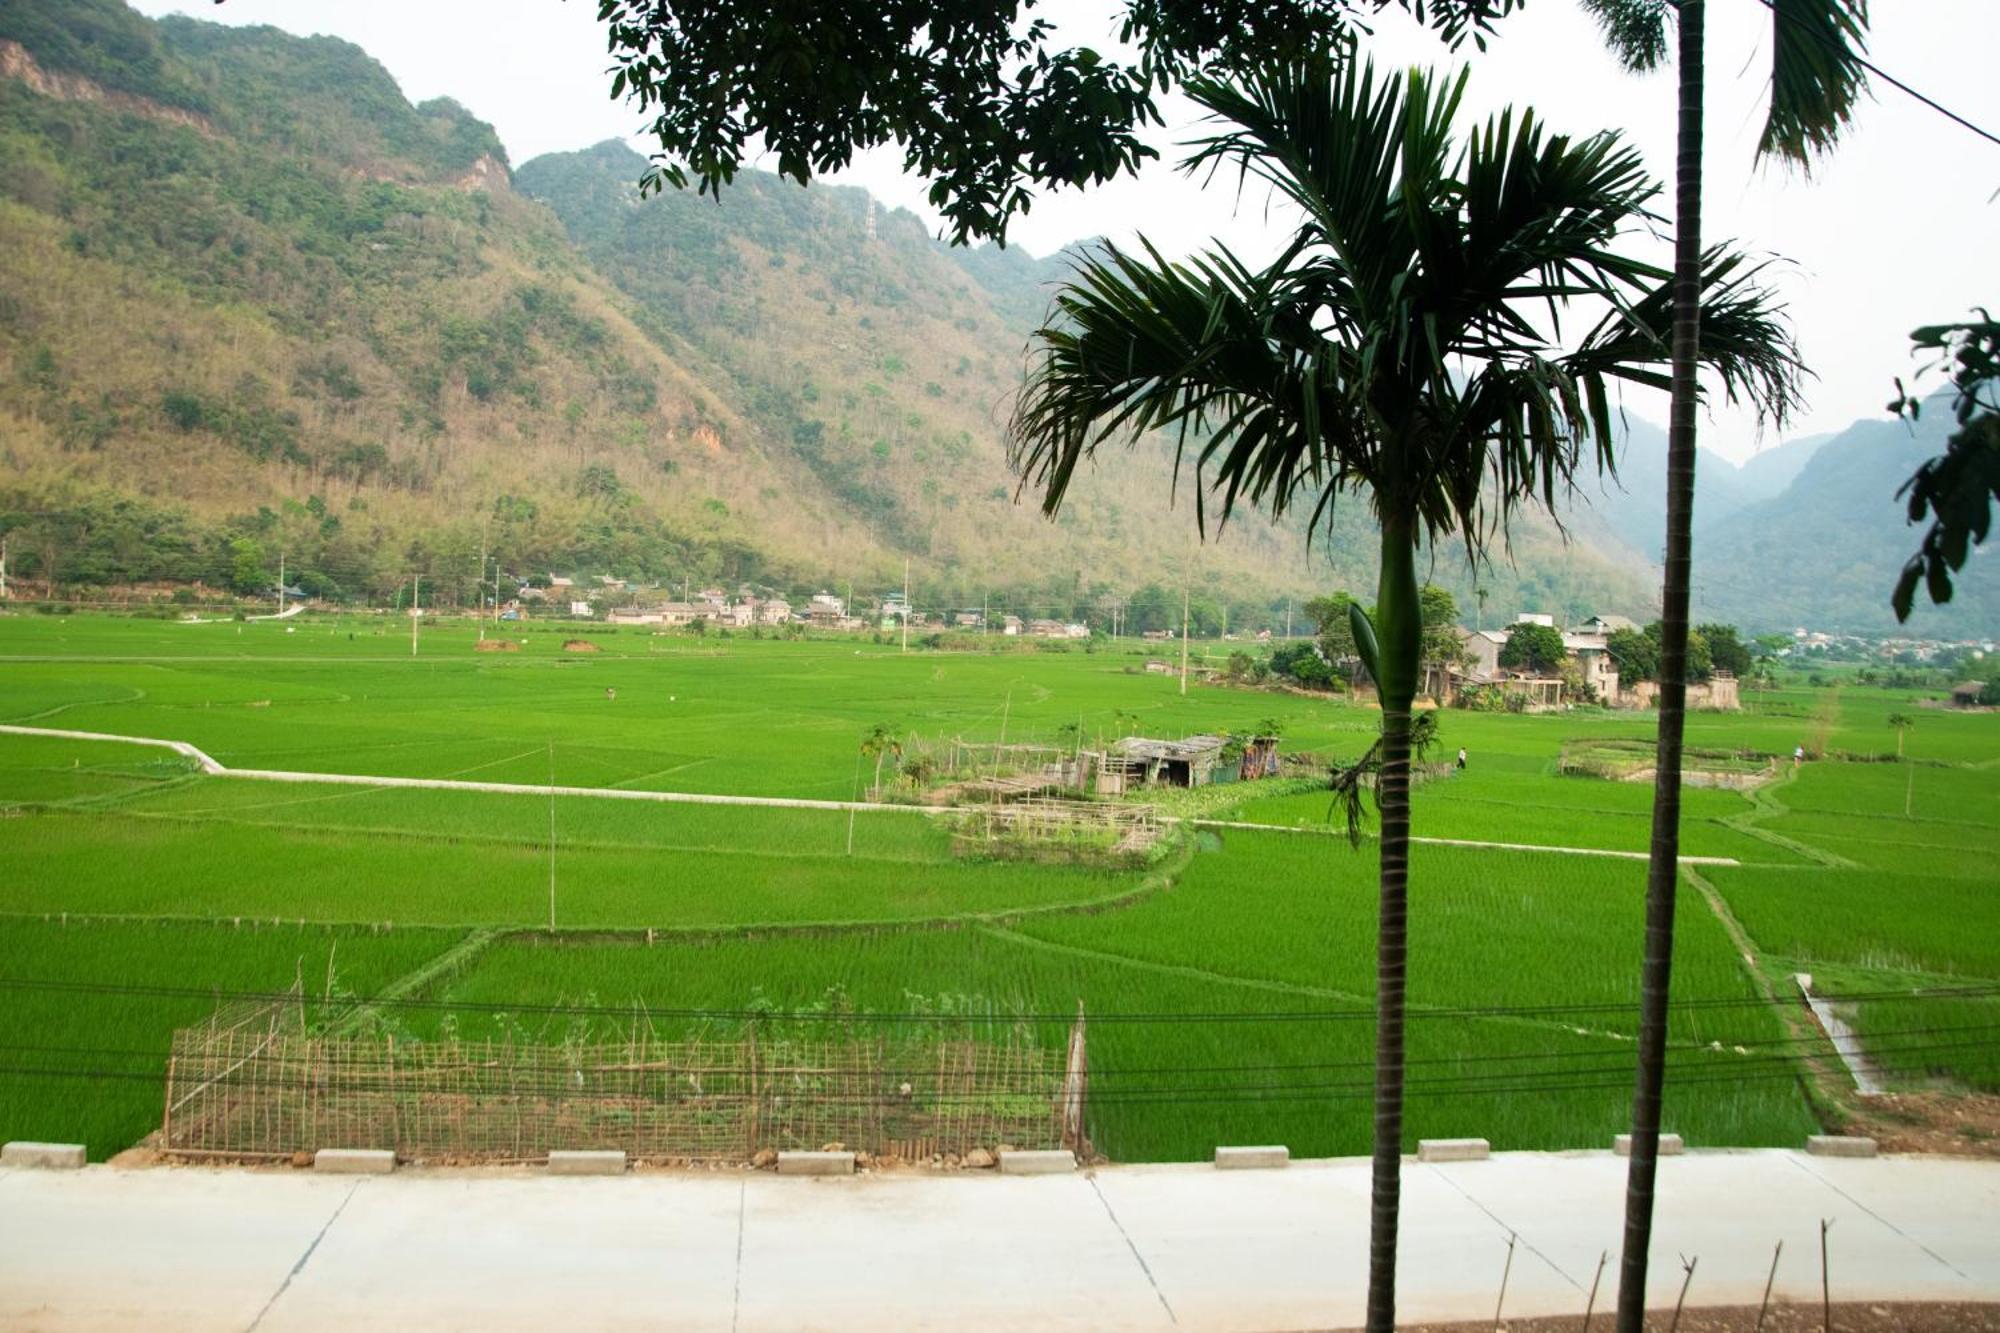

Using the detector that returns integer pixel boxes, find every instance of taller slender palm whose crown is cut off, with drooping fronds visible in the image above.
[1584,0,1868,1333]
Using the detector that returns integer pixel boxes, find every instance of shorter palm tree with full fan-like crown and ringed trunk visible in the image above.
[1010,56,1798,1329]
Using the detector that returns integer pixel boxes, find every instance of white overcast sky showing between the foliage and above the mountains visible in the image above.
[134,0,2000,460]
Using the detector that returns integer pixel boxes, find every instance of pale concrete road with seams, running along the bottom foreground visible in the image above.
[0,1151,2000,1333]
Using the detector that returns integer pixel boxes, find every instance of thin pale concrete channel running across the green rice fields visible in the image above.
[0,725,1742,867]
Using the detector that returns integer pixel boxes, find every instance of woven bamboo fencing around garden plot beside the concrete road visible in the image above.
[162,1001,1084,1161]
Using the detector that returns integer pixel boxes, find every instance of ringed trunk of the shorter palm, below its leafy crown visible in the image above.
[1368,520,1422,1333]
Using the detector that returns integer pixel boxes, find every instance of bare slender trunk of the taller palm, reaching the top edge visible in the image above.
[1618,0,1702,1333]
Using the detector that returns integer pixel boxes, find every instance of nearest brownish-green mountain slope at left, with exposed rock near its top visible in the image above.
[0,0,838,596]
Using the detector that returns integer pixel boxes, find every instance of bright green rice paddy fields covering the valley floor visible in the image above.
[0,616,2000,1159]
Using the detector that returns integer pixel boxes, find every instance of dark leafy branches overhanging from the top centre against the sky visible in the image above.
[598,0,1520,242]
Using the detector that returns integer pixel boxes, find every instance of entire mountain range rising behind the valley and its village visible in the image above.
[0,0,1986,626]
